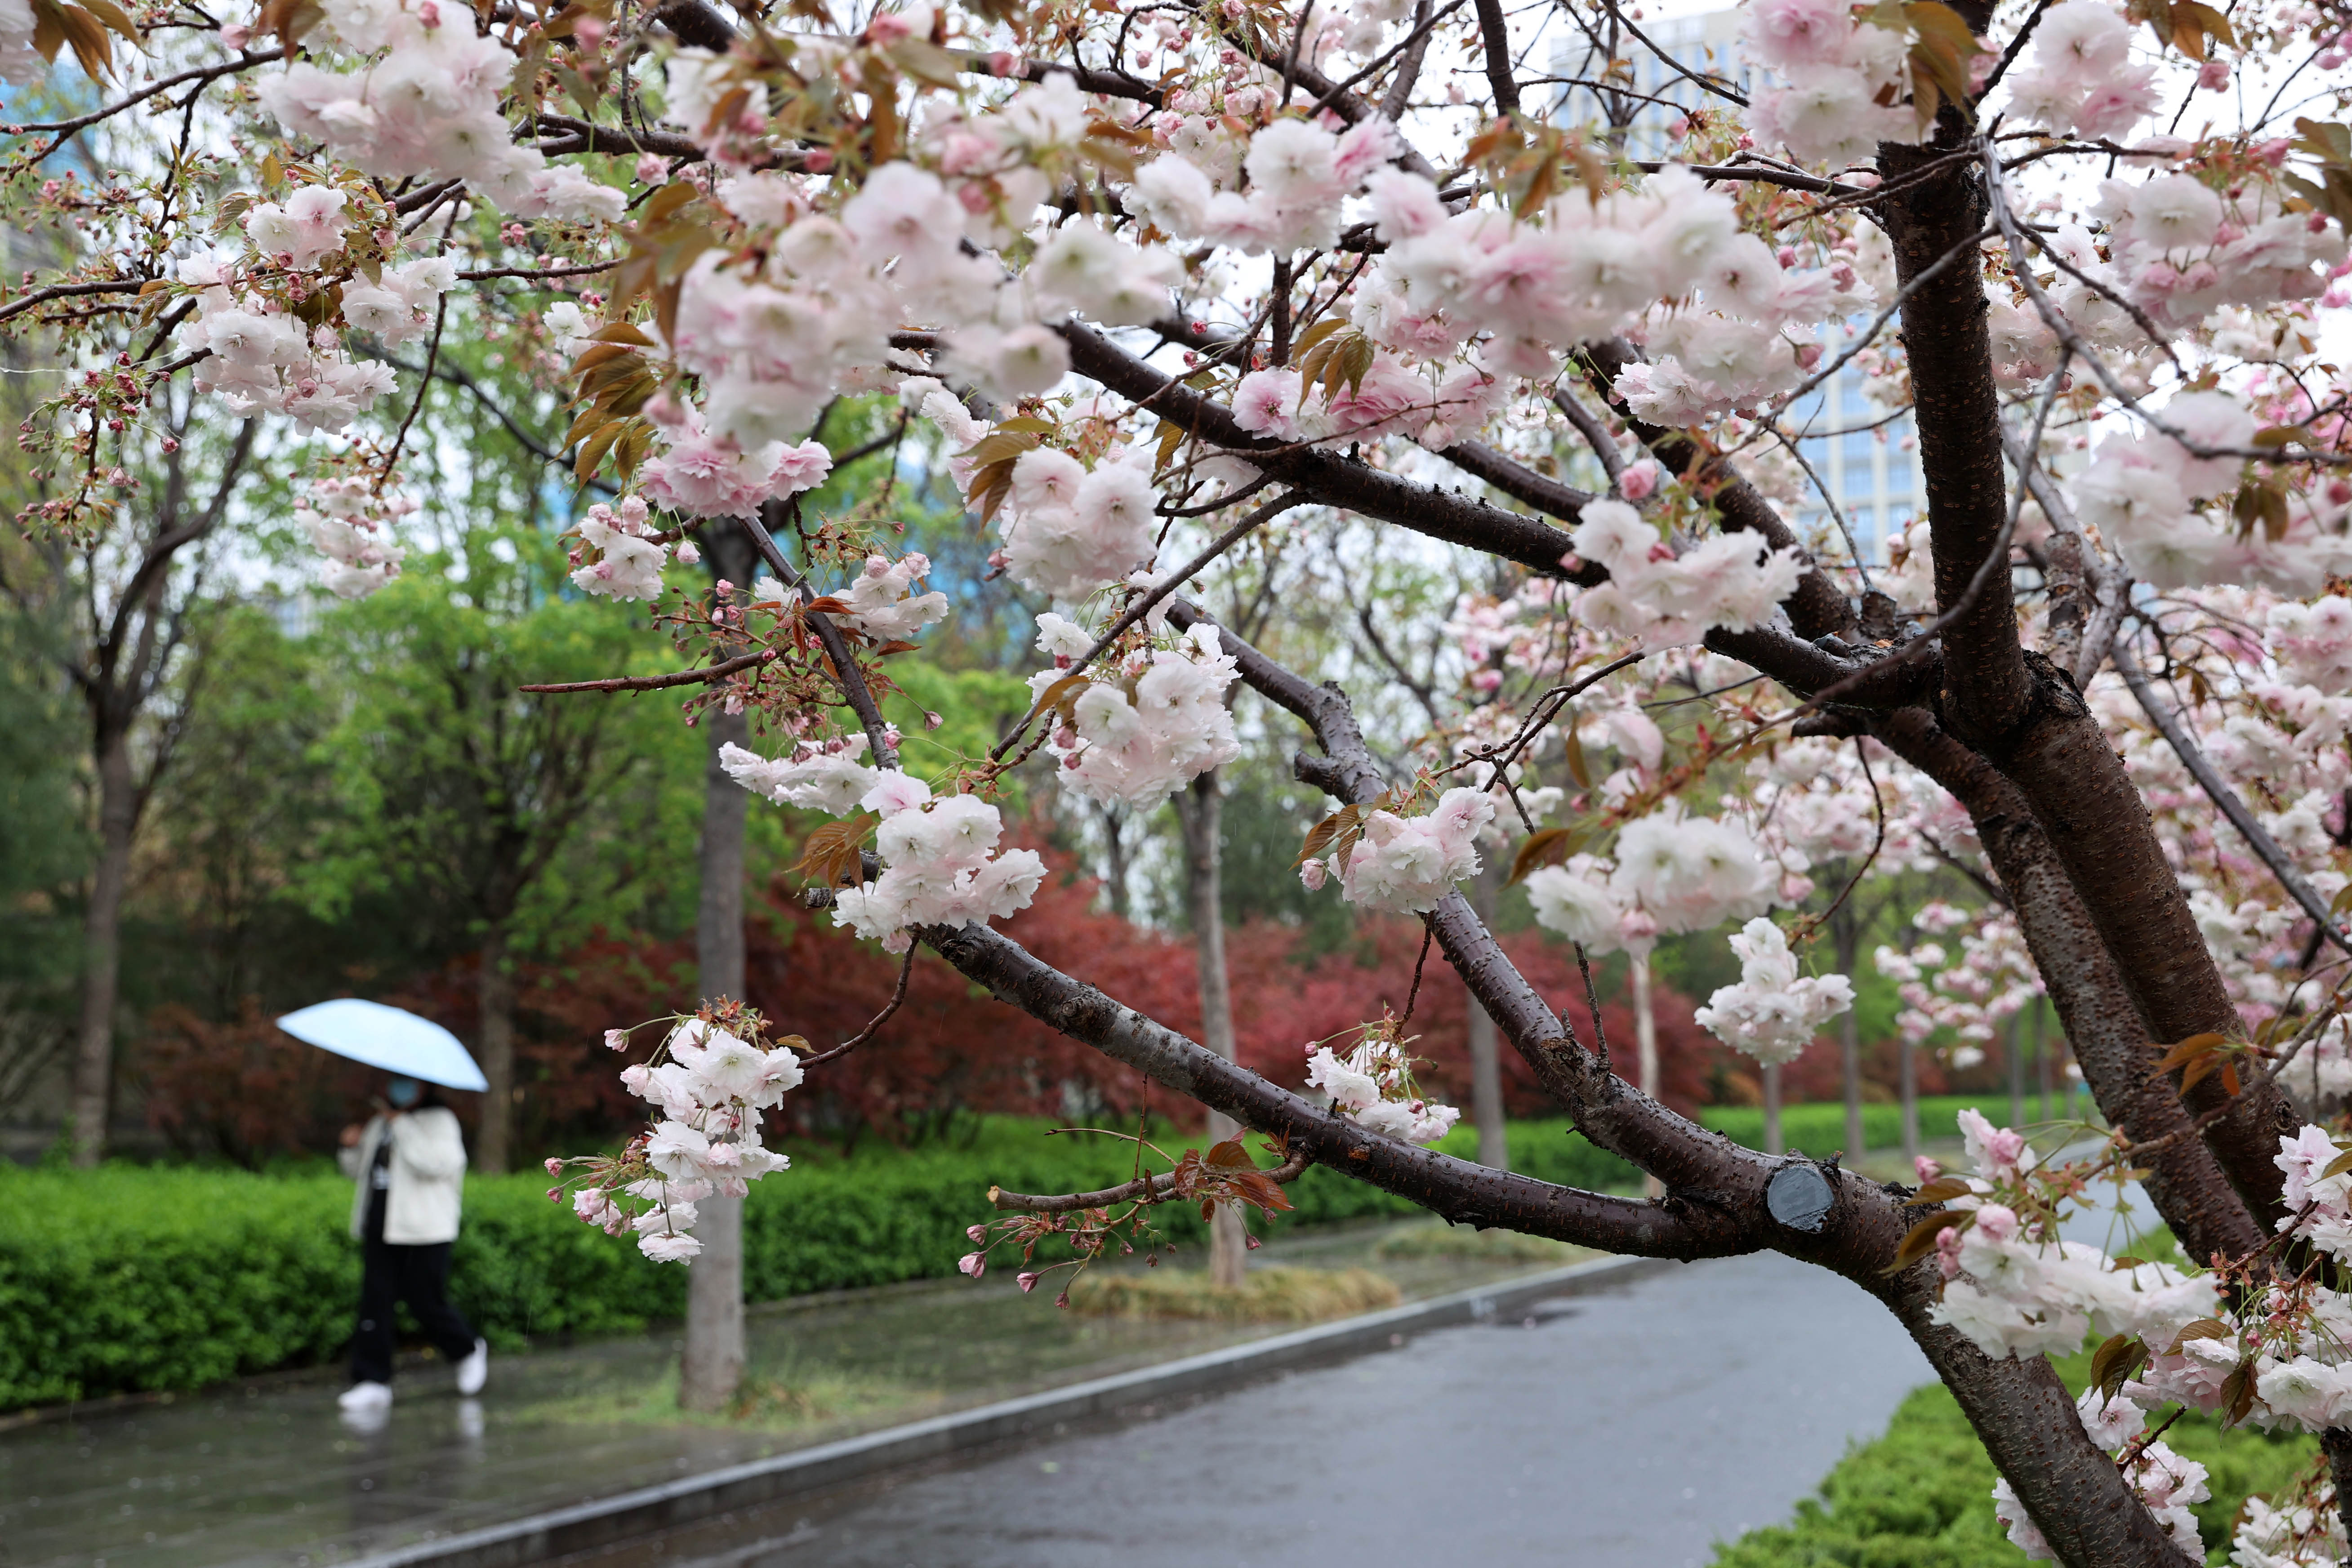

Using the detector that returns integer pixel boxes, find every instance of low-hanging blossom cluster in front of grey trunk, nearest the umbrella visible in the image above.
[548,1018,802,1262]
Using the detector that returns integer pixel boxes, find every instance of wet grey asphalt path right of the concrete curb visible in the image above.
[668,1255,1931,1568]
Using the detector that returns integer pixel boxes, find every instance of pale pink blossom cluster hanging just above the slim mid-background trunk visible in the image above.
[1030,611,1242,811]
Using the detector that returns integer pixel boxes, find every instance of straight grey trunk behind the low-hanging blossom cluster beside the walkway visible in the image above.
[677,710,750,1411]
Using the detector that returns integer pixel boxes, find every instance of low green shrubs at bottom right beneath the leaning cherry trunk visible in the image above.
[1715,1356,2317,1568]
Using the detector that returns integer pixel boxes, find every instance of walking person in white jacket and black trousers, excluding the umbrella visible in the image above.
[336,1077,489,1415]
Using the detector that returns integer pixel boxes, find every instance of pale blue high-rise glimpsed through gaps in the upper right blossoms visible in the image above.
[1552,9,1919,564]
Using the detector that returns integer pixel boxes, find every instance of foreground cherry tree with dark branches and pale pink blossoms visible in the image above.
[32,0,2352,1566]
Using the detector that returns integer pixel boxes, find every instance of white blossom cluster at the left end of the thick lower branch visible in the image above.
[720,736,1044,952]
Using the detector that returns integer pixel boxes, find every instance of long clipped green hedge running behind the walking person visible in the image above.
[0,1103,2022,1411]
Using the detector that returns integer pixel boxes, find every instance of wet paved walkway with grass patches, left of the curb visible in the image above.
[0,1222,1590,1568]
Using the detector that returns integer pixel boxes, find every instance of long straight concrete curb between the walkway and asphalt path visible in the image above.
[346,1258,1672,1568]
